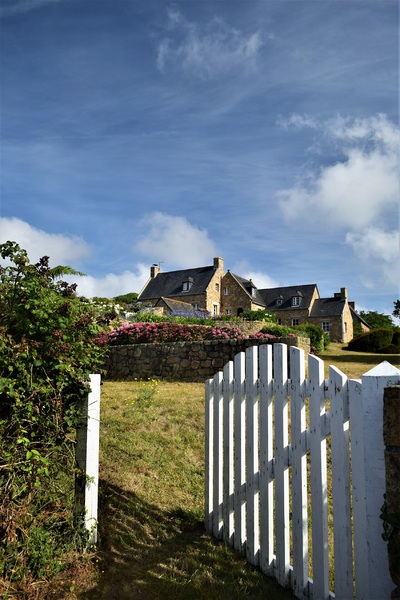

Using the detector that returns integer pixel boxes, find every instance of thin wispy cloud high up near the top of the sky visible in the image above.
[157,10,263,79]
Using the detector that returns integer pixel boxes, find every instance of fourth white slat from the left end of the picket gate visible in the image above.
[233,352,246,553]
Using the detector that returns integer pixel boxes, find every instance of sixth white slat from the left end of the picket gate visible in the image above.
[259,344,275,575]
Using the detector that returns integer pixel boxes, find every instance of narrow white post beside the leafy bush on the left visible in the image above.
[76,374,101,544]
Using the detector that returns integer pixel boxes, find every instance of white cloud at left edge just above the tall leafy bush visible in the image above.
[0,217,90,268]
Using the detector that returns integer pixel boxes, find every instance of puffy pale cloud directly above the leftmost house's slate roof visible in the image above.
[136,212,218,268]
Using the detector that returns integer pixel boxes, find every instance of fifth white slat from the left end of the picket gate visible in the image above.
[245,346,260,565]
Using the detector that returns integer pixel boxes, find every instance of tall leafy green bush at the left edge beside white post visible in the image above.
[0,242,104,588]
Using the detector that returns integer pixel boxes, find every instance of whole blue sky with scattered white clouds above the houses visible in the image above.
[0,0,399,313]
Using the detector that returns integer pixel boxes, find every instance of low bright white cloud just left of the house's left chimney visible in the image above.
[69,264,150,298]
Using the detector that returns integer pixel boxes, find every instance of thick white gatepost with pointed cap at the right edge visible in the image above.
[350,361,400,600]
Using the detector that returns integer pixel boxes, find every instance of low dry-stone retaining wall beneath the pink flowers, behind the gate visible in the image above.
[105,337,310,382]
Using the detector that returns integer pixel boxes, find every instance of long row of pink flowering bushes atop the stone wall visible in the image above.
[97,322,276,346]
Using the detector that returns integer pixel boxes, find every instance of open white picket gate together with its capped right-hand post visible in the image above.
[205,344,400,600]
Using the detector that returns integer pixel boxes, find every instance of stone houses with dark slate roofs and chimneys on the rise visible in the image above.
[138,257,368,343]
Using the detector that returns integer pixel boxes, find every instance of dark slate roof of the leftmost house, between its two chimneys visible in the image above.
[138,266,215,301]
